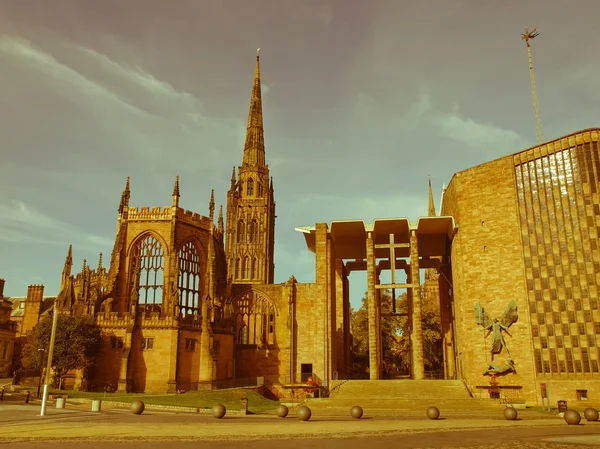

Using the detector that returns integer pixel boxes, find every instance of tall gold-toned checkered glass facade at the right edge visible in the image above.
[514,140,600,377]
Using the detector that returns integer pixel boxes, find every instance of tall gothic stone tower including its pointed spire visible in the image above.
[226,55,275,284]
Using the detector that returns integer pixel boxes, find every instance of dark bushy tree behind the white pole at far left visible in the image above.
[21,314,102,387]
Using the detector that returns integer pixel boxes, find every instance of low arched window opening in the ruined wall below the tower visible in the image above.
[235,292,277,346]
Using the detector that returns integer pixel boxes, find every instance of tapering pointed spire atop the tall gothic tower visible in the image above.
[242,49,265,166]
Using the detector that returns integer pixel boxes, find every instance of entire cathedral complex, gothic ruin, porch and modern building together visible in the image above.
[0,51,600,404]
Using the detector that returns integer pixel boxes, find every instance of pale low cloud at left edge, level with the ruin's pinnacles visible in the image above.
[0,200,114,251]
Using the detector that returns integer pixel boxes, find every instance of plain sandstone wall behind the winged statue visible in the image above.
[443,157,536,401]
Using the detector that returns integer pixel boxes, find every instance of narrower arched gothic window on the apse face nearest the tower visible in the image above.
[177,241,200,316]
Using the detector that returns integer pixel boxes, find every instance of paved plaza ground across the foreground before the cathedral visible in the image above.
[0,401,600,449]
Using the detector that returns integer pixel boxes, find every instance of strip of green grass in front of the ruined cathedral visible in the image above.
[50,388,279,413]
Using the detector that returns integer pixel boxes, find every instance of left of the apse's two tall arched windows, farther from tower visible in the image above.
[130,234,165,312]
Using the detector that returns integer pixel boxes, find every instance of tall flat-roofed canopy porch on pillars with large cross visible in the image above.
[296,217,458,380]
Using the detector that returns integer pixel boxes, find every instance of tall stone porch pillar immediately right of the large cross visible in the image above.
[410,229,425,380]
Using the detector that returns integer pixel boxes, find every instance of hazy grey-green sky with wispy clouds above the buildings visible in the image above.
[0,0,600,306]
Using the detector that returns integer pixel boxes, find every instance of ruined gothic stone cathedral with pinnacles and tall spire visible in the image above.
[22,56,300,392]
